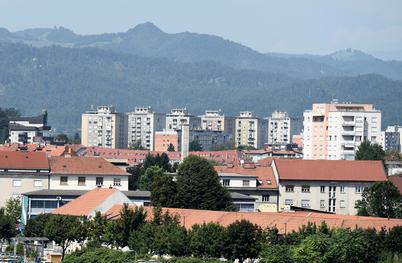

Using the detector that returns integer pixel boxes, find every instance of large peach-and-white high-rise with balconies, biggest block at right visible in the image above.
[303,100,381,160]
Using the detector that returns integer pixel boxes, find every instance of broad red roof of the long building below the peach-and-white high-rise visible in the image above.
[274,159,387,182]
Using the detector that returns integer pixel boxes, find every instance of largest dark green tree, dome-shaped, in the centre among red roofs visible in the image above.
[176,155,233,210]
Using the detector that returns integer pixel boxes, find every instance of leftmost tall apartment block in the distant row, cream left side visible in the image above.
[81,106,127,148]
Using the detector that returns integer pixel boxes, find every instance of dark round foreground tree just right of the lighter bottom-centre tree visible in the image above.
[223,220,262,262]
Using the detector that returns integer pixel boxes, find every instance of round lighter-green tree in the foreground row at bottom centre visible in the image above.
[189,223,225,258]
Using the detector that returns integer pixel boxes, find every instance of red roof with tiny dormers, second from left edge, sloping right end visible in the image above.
[49,156,128,175]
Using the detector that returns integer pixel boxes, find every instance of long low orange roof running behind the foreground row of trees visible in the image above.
[105,205,402,233]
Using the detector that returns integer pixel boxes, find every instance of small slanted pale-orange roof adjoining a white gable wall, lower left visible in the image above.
[52,188,118,216]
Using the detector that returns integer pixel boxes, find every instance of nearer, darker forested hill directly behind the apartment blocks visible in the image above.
[0,43,402,132]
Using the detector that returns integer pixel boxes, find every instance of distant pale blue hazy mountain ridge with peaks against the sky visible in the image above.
[0,22,402,80]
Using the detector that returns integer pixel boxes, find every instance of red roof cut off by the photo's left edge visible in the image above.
[0,151,49,170]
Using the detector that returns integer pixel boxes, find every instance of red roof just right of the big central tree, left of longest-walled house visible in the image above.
[214,166,278,189]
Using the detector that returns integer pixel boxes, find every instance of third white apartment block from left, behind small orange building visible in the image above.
[166,108,201,131]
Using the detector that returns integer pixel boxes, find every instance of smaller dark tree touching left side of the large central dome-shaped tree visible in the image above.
[151,173,177,207]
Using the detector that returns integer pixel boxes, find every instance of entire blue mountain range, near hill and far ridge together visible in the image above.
[0,23,402,133]
